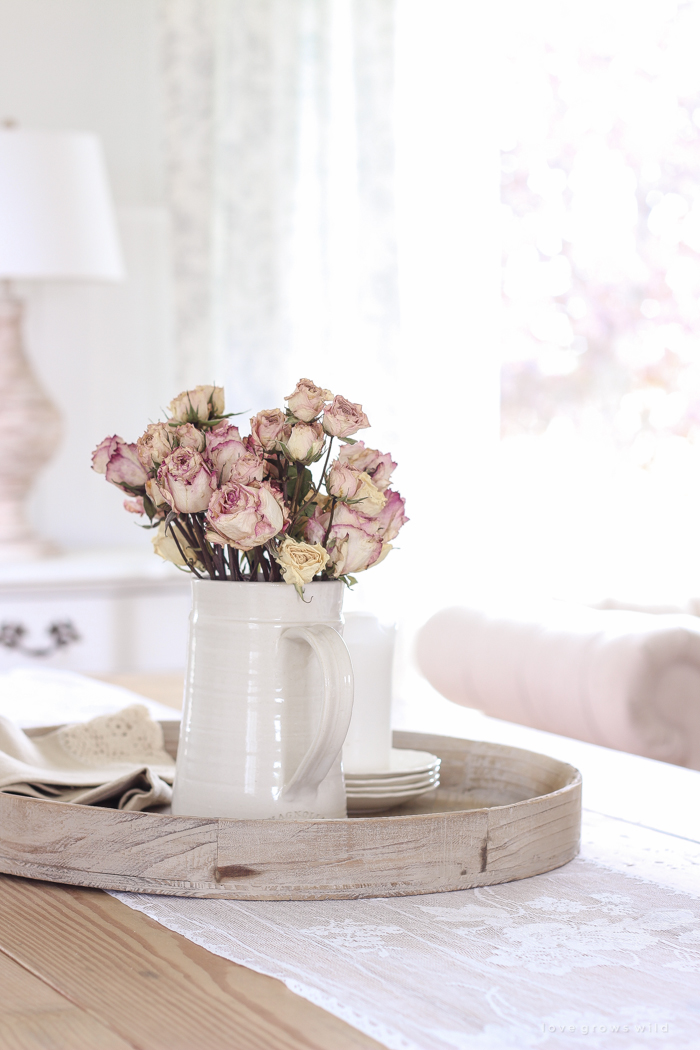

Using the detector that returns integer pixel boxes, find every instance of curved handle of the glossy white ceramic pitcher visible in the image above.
[281,624,353,799]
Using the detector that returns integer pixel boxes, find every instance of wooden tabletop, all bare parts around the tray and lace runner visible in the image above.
[6,675,700,1050]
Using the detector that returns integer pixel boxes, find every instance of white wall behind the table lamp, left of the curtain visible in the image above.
[0,0,177,548]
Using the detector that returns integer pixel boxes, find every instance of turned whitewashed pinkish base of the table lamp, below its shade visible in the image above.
[0,295,61,563]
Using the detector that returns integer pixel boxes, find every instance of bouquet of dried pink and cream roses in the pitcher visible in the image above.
[92,379,408,592]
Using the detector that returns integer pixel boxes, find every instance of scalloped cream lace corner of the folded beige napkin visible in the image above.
[56,704,172,767]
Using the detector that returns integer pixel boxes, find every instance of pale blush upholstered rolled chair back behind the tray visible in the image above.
[417,602,700,770]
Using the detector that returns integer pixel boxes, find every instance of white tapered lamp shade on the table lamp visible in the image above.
[0,128,124,280]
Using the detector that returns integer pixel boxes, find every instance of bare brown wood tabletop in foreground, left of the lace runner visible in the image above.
[0,876,379,1050]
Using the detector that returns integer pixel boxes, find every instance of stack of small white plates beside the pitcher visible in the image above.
[345,748,440,813]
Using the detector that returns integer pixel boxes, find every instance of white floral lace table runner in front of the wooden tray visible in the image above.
[113,813,700,1050]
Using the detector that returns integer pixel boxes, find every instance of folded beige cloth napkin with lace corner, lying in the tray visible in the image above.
[0,704,175,810]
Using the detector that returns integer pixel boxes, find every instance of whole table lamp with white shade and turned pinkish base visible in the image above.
[0,125,124,562]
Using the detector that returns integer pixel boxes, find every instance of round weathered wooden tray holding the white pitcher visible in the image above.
[0,722,581,901]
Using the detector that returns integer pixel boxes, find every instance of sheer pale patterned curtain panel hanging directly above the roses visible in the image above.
[162,0,398,411]
